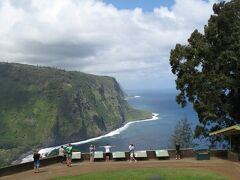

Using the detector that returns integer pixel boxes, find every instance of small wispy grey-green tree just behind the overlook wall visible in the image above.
[172,118,193,148]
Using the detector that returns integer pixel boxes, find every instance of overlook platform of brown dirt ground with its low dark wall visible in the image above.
[0,149,240,180]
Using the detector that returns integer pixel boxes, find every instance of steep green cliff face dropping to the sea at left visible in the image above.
[0,63,150,165]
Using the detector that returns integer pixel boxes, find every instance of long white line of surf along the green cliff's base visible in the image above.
[21,113,159,163]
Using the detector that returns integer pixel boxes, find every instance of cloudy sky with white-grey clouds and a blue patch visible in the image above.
[0,0,218,89]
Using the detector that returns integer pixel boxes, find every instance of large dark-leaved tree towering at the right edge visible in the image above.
[170,0,240,135]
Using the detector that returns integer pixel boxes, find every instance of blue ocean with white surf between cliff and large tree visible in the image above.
[23,90,198,162]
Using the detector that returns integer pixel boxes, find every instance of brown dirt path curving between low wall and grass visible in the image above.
[0,158,240,180]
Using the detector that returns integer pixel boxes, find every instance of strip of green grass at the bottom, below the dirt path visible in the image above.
[53,168,227,180]
